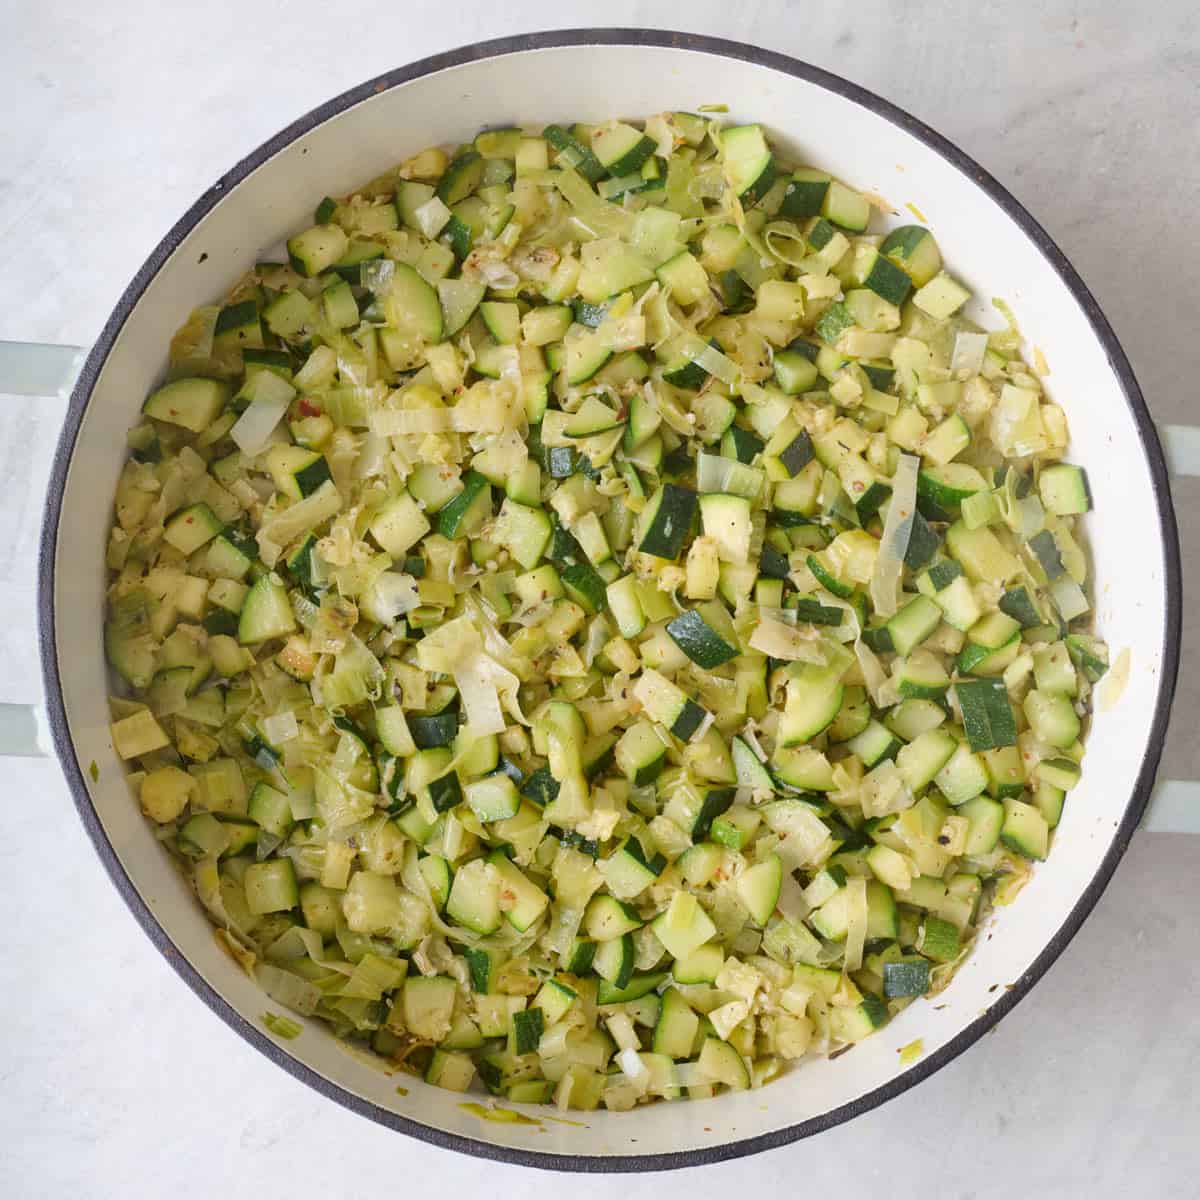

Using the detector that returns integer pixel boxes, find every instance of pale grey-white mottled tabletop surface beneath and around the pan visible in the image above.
[0,0,1200,1200]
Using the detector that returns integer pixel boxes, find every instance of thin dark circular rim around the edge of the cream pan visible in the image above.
[37,29,1181,1172]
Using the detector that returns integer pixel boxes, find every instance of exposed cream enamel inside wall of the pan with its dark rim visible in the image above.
[41,30,1180,1170]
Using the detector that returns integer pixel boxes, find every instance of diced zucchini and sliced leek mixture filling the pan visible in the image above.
[106,113,1108,1109]
